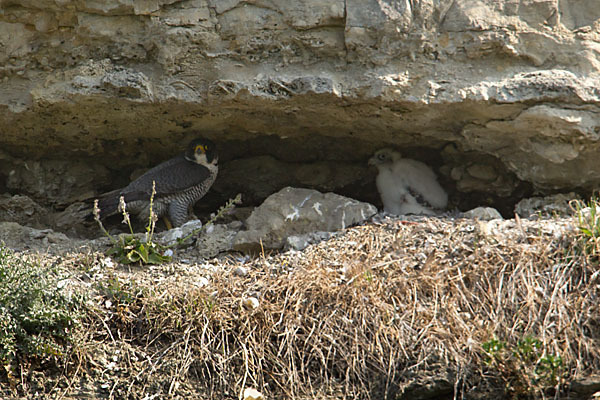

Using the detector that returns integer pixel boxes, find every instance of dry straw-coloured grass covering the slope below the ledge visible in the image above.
[1,219,600,399]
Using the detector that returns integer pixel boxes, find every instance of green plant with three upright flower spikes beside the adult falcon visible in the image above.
[94,182,171,264]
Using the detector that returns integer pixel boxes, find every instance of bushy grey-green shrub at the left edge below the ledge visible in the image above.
[0,244,84,385]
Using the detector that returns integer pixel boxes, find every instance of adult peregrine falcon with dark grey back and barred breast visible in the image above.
[98,138,219,229]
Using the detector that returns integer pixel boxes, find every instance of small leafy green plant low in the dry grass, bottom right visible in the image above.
[481,336,563,396]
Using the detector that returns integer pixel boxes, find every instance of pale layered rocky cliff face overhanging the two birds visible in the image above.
[0,0,600,228]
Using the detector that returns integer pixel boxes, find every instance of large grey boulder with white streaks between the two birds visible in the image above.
[234,187,377,251]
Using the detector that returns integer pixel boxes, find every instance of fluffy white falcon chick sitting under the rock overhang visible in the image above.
[369,149,448,215]
